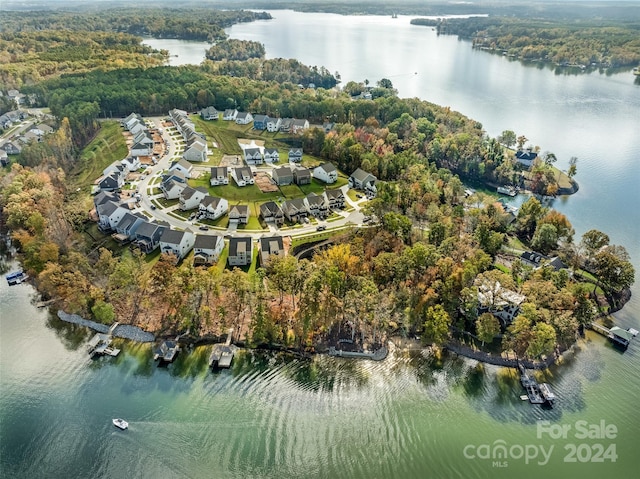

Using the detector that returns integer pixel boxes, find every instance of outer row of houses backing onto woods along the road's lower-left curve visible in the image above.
[94,191,286,266]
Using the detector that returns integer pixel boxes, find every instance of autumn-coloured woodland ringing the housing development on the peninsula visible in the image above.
[0,6,635,359]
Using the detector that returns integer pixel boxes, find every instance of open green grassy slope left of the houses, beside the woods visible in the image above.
[70,121,129,188]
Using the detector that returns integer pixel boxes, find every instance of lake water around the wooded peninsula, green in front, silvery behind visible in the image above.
[5,11,640,479]
